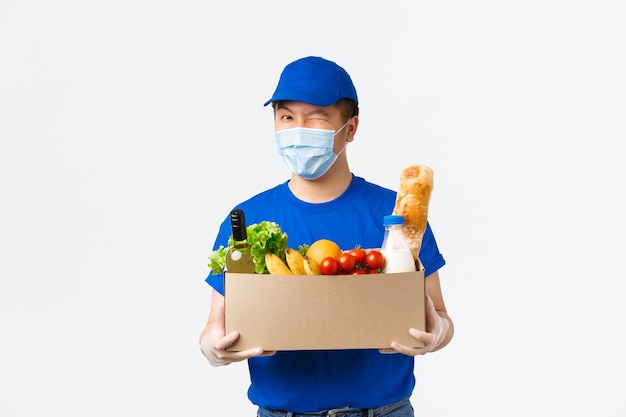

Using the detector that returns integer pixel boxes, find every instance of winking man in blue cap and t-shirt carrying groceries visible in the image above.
[200,56,454,417]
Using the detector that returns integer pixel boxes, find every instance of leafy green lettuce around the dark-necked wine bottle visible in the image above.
[209,221,287,274]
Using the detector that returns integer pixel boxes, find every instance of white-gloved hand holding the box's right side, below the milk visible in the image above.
[379,296,450,356]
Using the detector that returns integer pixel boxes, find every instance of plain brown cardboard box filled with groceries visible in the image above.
[224,269,426,351]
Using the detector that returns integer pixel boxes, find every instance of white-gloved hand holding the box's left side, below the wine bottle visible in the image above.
[200,302,275,366]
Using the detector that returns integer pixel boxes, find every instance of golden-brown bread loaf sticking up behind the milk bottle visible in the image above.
[393,165,433,262]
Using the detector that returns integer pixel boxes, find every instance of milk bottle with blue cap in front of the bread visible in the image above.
[380,215,416,273]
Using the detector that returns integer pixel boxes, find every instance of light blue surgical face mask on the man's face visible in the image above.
[276,120,349,180]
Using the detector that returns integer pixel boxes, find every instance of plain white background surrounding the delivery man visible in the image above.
[0,0,626,417]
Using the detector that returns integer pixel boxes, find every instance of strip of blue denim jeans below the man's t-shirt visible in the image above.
[257,398,415,417]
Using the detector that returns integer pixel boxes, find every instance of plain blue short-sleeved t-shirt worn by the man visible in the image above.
[206,176,445,412]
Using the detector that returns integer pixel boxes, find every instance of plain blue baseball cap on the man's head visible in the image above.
[263,56,359,107]
